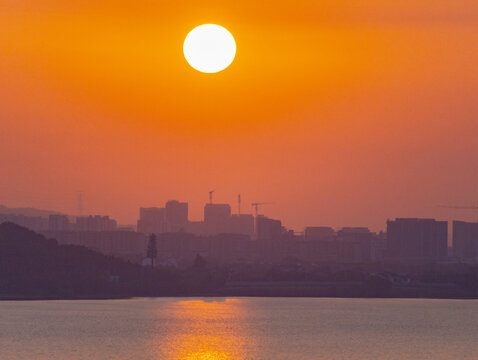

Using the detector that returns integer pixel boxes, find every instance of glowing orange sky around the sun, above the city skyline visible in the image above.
[0,0,478,230]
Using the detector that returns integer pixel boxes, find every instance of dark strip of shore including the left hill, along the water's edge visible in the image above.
[0,223,478,301]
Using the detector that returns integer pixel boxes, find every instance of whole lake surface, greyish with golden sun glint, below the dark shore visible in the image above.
[0,298,478,360]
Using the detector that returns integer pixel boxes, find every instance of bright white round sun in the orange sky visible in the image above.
[183,24,236,73]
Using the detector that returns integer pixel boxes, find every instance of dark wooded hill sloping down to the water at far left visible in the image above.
[0,223,168,299]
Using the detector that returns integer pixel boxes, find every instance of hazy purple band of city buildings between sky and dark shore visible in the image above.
[4,200,478,268]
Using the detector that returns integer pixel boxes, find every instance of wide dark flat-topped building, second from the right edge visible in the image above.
[387,218,448,261]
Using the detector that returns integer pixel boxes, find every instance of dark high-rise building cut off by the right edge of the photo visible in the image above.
[453,221,478,261]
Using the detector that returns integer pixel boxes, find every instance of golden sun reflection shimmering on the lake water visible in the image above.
[157,299,253,360]
